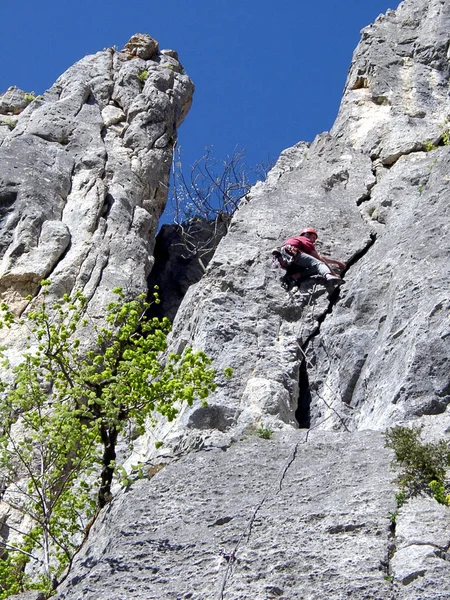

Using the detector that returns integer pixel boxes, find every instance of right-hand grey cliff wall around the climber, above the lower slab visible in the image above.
[162,0,450,433]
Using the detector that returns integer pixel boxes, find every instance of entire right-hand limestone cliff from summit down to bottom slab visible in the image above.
[4,0,450,600]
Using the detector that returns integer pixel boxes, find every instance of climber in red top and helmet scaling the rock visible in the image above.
[281,227,346,285]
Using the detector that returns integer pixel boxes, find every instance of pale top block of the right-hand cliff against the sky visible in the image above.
[332,0,450,165]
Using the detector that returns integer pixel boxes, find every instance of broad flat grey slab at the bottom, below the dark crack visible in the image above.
[56,431,394,600]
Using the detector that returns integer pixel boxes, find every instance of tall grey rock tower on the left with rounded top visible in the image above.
[0,34,193,316]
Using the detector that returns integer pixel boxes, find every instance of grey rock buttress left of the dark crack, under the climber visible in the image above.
[163,135,375,436]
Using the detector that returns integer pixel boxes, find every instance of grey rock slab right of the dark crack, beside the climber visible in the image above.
[311,147,450,431]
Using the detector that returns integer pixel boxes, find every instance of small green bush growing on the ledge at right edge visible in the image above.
[385,426,450,506]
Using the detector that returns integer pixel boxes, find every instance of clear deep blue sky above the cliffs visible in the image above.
[0,0,399,202]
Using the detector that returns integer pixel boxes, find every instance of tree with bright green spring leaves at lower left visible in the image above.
[0,281,219,598]
